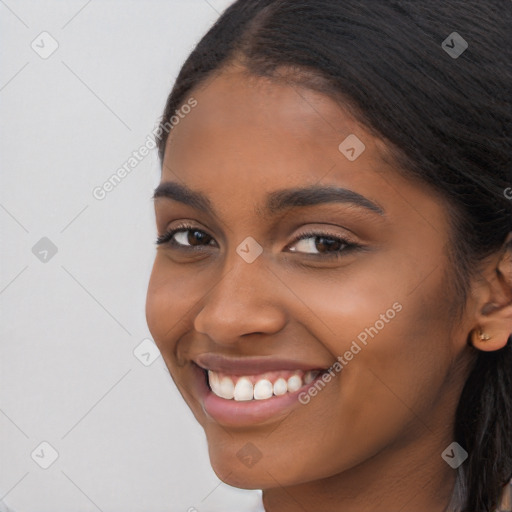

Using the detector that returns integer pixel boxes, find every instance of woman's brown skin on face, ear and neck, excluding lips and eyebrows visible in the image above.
[146,66,512,512]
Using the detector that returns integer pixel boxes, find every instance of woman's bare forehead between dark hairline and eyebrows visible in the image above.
[161,64,443,238]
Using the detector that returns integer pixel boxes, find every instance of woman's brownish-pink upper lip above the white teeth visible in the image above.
[193,352,325,375]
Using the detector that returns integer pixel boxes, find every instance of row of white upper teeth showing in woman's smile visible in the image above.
[208,370,320,401]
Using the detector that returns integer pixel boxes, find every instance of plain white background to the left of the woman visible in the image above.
[0,0,258,512]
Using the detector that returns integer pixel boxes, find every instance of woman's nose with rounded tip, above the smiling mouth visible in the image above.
[194,253,286,346]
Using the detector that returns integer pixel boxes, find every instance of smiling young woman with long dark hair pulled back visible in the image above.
[146,0,512,512]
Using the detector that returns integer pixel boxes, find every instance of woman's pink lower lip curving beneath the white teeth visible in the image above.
[193,364,328,427]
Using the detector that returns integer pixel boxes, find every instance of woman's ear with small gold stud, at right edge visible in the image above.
[471,232,512,352]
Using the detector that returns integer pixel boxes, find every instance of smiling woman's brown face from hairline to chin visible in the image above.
[146,68,471,491]
